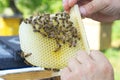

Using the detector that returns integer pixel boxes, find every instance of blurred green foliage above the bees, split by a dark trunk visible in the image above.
[0,0,63,17]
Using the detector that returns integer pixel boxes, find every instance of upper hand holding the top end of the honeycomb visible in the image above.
[63,0,120,22]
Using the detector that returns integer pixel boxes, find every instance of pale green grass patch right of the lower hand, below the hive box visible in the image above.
[103,48,120,80]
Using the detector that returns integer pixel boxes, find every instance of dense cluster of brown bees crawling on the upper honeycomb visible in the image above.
[24,12,80,52]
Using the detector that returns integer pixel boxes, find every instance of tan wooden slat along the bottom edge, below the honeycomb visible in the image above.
[1,71,60,80]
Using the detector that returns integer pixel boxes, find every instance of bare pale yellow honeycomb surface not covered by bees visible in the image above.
[19,6,88,69]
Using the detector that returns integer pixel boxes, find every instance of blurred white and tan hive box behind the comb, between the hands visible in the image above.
[83,18,112,50]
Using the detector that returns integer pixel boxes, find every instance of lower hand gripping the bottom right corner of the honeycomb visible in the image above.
[61,51,114,80]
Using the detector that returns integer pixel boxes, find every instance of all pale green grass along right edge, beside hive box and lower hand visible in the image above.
[102,20,120,80]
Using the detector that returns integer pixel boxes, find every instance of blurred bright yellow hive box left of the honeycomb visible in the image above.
[0,16,22,36]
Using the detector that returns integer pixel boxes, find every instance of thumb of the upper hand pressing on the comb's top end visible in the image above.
[80,0,110,16]
